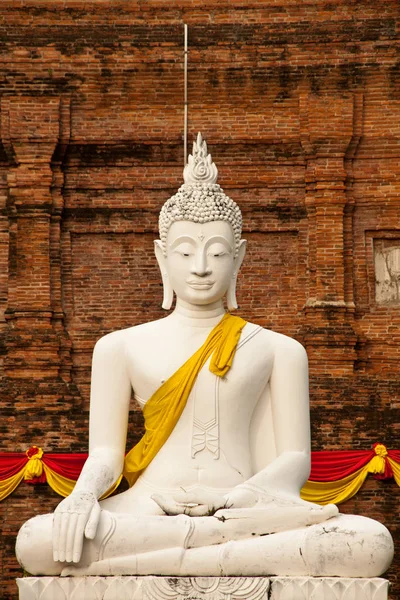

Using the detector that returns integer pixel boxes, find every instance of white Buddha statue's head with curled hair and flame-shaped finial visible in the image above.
[155,133,246,310]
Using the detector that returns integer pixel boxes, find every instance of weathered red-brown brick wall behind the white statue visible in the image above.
[0,0,400,600]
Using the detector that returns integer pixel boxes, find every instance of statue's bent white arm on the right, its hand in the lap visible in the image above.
[229,336,310,504]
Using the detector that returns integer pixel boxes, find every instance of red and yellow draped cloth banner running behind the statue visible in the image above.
[0,444,400,504]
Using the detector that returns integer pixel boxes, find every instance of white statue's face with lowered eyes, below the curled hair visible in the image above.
[165,221,237,305]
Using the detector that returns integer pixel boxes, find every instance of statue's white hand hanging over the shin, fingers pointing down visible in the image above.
[53,491,101,563]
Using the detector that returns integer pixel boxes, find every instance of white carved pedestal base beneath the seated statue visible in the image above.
[17,576,389,600]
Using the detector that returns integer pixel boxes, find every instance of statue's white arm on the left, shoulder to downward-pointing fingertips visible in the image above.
[53,332,131,562]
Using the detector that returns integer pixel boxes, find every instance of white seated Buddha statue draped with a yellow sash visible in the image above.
[17,134,393,577]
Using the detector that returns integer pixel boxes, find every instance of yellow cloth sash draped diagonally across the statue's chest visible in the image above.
[124,313,246,486]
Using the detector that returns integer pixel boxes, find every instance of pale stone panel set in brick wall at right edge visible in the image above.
[374,239,400,305]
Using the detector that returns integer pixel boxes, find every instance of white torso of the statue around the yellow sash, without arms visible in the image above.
[101,318,275,502]
